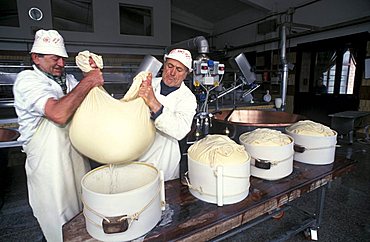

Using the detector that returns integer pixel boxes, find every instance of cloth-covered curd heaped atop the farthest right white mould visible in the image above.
[286,120,335,136]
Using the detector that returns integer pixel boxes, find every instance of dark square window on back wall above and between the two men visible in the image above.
[119,5,153,36]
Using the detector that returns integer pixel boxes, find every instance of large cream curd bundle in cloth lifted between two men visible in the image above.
[69,72,155,164]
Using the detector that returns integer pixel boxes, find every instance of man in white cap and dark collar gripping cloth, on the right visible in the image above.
[139,49,197,180]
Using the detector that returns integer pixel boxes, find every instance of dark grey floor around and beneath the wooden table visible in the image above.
[0,134,370,242]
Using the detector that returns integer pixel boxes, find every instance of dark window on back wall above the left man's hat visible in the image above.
[51,0,94,32]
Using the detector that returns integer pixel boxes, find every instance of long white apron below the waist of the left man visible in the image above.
[24,119,90,242]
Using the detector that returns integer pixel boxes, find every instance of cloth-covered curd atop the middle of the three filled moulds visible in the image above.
[240,128,292,146]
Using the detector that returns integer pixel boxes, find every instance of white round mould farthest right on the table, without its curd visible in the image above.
[285,129,337,165]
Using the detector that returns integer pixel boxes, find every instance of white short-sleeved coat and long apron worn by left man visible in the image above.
[14,65,90,242]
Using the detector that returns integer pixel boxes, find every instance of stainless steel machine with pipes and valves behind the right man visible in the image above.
[165,36,259,137]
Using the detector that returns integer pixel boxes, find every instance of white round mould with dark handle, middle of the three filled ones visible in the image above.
[239,133,294,180]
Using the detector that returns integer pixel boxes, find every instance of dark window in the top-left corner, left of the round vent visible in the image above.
[0,0,19,27]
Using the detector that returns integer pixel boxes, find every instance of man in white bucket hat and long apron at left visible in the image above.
[13,30,104,242]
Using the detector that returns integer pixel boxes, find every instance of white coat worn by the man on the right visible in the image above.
[139,78,197,181]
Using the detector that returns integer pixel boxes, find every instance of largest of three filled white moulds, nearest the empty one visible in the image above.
[188,155,250,206]
